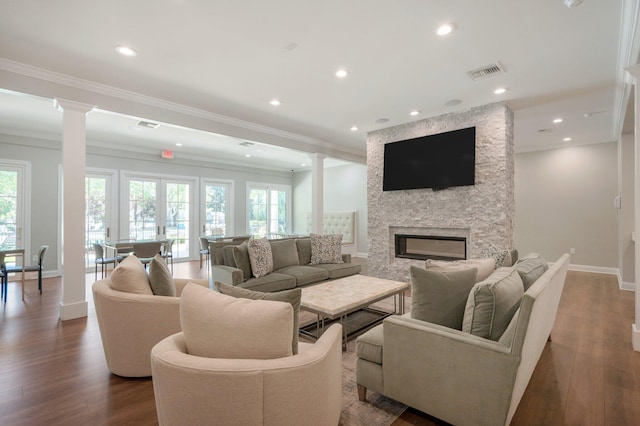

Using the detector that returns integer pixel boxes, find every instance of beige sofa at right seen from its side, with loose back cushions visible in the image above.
[356,254,569,425]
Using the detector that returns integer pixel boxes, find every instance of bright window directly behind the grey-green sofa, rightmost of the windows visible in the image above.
[248,184,291,238]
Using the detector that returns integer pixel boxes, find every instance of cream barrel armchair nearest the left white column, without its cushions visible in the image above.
[92,277,209,377]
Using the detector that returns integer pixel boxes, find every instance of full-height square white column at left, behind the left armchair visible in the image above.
[55,99,93,321]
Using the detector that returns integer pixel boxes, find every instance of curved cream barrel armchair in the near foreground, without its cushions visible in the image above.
[151,324,342,426]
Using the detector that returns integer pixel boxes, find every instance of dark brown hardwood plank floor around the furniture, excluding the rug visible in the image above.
[0,262,640,426]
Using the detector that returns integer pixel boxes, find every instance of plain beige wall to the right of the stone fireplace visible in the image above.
[515,142,618,268]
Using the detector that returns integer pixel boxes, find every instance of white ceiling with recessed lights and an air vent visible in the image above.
[0,0,639,170]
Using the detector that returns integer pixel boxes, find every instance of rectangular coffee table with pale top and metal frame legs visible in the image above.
[300,274,409,347]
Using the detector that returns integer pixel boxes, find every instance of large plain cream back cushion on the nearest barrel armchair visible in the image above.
[180,283,293,359]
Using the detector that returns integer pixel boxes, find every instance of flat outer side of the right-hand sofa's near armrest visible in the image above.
[382,315,520,425]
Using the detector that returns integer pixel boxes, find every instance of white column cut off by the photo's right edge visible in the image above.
[628,65,640,352]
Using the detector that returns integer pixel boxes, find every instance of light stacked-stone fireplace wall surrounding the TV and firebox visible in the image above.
[367,103,515,281]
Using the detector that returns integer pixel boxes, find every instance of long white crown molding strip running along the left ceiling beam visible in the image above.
[0,58,364,160]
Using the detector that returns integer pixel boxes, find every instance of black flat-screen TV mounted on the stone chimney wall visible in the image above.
[382,127,476,191]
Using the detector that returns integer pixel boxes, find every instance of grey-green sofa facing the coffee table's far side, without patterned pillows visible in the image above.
[209,238,361,292]
